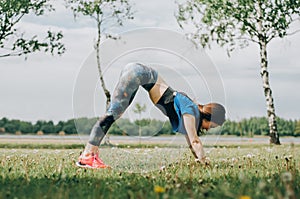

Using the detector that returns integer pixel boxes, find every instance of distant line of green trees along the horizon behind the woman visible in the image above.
[0,117,300,137]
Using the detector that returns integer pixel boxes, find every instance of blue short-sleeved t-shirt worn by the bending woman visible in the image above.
[172,92,200,134]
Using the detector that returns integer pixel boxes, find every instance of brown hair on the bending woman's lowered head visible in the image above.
[198,103,226,126]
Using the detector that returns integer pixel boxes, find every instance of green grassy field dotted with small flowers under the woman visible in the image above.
[0,144,300,199]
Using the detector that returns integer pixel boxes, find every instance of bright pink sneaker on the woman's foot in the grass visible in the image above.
[76,154,110,169]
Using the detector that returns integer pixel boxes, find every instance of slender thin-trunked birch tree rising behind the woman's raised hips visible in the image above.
[66,0,133,107]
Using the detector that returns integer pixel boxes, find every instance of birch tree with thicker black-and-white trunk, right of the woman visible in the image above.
[176,0,300,144]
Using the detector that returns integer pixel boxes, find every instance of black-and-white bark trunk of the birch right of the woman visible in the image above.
[259,38,280,144]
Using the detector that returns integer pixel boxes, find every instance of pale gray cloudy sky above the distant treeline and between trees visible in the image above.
[0,0,300,121]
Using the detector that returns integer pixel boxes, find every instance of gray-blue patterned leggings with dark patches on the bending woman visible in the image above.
[89,63,158,146]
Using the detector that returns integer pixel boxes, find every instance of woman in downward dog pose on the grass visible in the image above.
[76,63,225,168]
